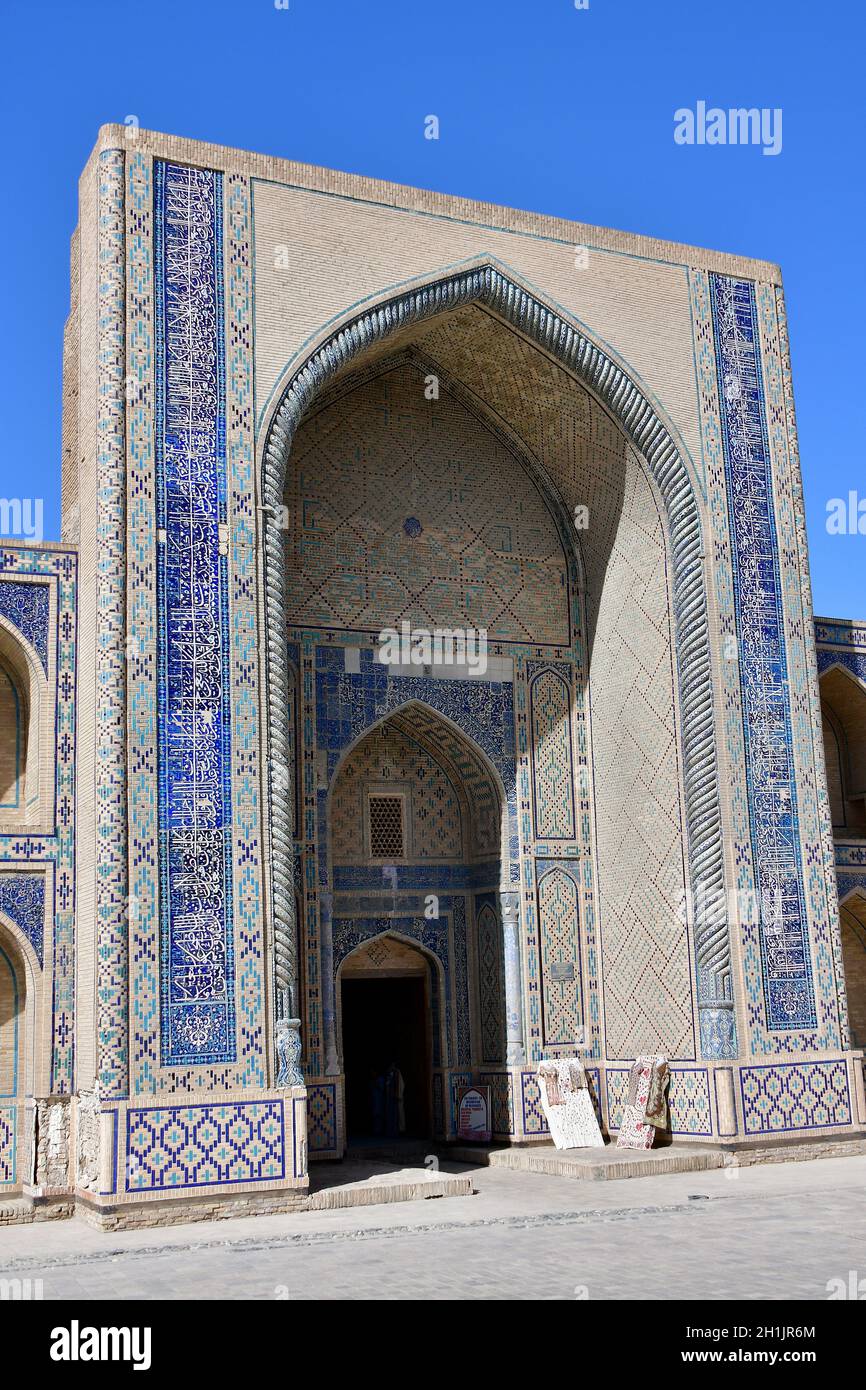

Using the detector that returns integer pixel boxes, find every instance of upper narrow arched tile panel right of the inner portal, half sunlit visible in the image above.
[530,671,574,840]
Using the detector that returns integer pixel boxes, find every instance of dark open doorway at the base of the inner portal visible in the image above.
[342,976,432,1140]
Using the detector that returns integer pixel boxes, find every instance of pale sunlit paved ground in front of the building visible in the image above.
[0,1156,866,1300]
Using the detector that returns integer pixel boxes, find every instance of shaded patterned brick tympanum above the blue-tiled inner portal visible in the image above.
[286,364,569,645]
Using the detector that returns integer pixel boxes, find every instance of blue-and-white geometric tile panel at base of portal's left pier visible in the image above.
[125,1101,286,1193]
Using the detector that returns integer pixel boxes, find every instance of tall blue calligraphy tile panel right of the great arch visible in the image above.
[710,275,817,1030]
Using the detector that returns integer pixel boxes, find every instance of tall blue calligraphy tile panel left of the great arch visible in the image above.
[154,164,236,1066]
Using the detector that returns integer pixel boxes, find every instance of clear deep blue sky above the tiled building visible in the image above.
[0,0,866,617]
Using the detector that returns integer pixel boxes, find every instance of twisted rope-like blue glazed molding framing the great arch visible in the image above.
[263,265,737,1058]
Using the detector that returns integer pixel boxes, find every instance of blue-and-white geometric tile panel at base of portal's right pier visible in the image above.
[740,1061,852,1134]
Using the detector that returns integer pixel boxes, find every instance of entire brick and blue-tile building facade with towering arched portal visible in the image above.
[0,126,866,1225]
